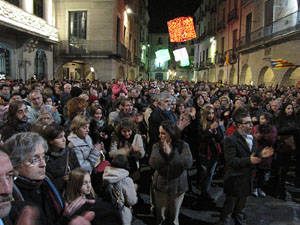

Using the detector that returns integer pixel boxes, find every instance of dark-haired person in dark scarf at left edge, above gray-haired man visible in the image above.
[0,101,30,141]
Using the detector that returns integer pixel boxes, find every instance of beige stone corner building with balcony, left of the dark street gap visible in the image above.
[55,0,149,80]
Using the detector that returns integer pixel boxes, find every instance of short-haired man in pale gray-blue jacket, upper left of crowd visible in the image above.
[27,91,61,124]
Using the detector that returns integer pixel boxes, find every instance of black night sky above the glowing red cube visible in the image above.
[148,0,199,33]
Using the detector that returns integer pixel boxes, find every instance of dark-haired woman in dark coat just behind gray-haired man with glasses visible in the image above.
[42,123,80,193]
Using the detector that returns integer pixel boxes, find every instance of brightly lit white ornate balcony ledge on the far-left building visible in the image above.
[0,1,59,43]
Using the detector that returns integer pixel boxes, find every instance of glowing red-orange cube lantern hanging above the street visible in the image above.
[168,16,197,42]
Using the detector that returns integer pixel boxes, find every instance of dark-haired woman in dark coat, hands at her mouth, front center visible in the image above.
[149,120,193,224]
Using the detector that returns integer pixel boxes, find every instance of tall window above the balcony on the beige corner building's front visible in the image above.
[69,11,87,51]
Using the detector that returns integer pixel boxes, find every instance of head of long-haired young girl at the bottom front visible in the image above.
[65,168,95,203]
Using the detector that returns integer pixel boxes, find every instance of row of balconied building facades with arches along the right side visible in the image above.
[195,0,300,86]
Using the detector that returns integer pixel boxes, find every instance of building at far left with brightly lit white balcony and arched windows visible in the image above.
[0,0,59,80]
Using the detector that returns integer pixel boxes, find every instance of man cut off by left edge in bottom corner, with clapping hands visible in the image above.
[0,151,94,225]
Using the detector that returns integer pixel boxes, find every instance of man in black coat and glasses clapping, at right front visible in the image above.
[217,109,274,225]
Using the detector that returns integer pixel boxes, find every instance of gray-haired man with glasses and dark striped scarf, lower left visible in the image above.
[4,132,94,225]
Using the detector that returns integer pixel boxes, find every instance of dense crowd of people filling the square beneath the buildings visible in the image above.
[0,79,300,225]
